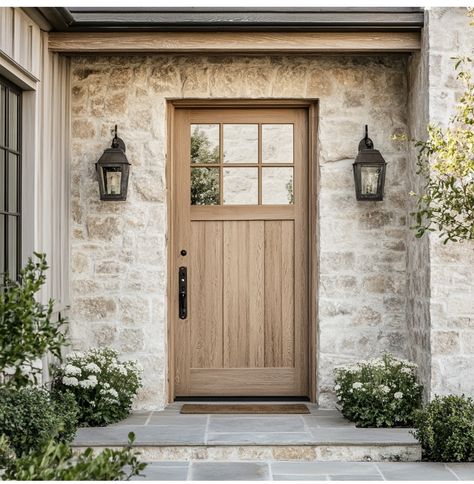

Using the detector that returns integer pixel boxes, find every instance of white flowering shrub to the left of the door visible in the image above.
[53,348,142,426]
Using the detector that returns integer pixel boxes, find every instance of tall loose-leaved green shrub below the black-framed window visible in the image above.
[0,253,66,388]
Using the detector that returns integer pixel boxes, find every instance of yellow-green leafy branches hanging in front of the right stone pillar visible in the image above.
[412,57,474,243]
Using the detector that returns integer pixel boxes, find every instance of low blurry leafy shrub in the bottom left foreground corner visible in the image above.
[3,433,146,481]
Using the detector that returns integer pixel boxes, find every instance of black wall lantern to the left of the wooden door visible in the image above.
[95,125,130,200]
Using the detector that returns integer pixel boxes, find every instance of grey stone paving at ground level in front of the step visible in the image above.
[134,461,474,481]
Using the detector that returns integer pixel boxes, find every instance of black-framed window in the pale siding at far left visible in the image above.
[0,76,21,279]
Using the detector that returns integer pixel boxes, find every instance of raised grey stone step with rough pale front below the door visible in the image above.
[74,411,421,462]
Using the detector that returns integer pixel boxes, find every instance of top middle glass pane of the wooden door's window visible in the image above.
[224,124,258,163]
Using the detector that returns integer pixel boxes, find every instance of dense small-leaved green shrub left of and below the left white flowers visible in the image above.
[0,387,78,456]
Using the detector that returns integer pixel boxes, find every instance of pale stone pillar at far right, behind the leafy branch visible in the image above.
[428,8,474,395]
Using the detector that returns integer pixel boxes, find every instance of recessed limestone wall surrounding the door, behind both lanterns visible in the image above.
[71,55,408,408]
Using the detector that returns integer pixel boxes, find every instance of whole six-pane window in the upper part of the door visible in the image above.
[190,123,294,205]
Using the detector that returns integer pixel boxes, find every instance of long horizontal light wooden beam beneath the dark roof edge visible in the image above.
[49,32,420,54]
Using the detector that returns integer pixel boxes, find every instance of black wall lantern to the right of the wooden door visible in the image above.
[352,125,387,201]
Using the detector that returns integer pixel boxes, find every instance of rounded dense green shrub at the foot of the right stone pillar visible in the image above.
[413,395,474,462]
